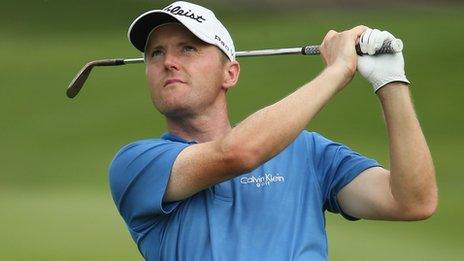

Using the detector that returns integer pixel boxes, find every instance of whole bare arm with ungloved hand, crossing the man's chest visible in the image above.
[164,26,366,202]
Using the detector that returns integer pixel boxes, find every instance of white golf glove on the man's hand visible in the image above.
[358,29,410,92]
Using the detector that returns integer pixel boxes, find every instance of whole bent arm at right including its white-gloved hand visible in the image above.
[338,29,438,220]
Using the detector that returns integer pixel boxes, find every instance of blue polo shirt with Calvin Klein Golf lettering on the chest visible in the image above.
[109,131,379,261]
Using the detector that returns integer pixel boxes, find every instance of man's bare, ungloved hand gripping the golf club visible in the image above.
[319,25,368,85]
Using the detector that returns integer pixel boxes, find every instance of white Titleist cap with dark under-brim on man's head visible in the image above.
[127,1,235,61]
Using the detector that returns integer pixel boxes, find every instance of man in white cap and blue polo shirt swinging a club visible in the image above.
[109,2,437,260]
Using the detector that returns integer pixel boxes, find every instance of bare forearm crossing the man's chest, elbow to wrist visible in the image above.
[222,67,349,170]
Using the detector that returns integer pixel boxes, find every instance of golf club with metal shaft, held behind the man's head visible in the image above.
[66,39,403,98]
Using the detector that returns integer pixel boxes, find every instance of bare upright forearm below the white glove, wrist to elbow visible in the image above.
[378,83,437,216]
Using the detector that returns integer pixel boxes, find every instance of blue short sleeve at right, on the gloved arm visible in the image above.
[308,133,380,220]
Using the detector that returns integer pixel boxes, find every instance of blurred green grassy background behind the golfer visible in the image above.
[0,0,464,260]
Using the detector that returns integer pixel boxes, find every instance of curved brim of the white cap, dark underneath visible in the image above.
[127,10,181,53]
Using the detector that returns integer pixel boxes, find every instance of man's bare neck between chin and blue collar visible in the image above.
[166,99,232,143]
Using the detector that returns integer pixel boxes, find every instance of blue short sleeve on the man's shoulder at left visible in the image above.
[109,139,188,230]
